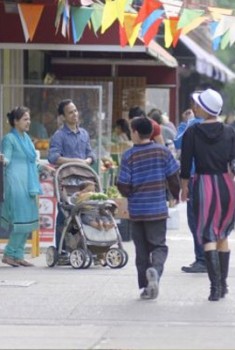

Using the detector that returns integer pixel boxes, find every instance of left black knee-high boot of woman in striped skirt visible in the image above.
[205,250,221,301]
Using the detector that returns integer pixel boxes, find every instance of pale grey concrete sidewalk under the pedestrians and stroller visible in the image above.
[0,204,235,350]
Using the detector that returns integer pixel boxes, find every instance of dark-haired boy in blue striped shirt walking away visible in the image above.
[117,117,180,299]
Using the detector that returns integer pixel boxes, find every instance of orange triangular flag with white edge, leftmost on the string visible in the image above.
[18,4,44,41]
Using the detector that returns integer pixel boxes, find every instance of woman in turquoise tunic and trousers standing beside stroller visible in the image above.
[1,107,51,267]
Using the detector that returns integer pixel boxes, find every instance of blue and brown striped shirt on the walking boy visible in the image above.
[117,142,179,221]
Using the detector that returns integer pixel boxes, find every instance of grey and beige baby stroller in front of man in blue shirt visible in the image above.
[46,162,128,269]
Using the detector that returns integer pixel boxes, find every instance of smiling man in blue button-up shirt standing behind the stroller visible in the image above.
[48,99,96,250]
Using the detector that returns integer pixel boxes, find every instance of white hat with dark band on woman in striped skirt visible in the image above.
[192,89,223,117]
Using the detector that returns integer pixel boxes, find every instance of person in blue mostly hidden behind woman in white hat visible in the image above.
[174,100,207,273]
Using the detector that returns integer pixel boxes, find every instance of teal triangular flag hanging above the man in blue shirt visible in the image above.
[71,6,93,43]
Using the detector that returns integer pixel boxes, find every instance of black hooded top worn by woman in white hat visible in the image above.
[181,122,235,179]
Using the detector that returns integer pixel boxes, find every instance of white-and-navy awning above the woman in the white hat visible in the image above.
[180,35,235,82]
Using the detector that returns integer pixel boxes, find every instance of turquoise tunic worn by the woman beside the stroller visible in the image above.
[1,133,39,233]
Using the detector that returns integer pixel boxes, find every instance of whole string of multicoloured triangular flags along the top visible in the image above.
[14,0,235,50]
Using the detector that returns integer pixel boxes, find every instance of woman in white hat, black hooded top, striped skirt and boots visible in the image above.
[181,89,235,301]
